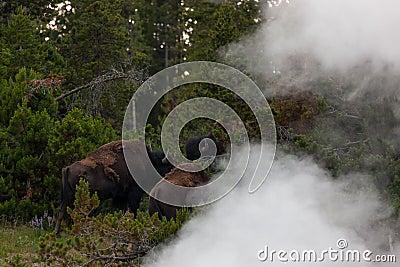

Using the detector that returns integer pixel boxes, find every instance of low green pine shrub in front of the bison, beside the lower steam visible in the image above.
[39,179,189,266]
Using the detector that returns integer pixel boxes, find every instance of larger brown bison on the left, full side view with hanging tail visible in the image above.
[55,140,173,234]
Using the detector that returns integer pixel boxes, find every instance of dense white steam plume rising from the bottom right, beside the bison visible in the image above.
[146,146,396,267]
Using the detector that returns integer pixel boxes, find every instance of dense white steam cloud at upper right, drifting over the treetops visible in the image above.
[221,0,400,97]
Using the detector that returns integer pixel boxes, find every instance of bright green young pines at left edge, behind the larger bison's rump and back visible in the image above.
[0,68,116,219]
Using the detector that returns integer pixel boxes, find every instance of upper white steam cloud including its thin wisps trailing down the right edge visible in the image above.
[220,0,400,142]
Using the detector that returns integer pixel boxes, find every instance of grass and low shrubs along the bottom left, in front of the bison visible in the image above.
[0,180,190,266]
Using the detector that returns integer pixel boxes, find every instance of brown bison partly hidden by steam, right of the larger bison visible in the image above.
[148,163,210,220]
